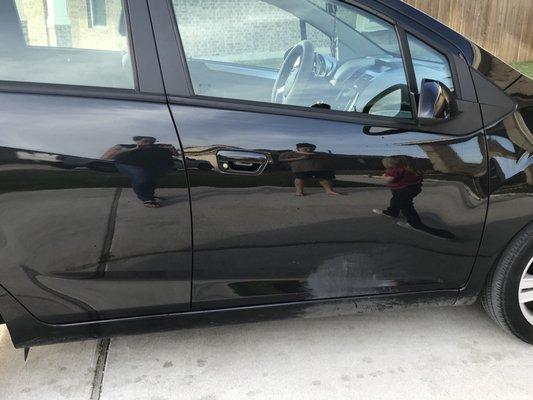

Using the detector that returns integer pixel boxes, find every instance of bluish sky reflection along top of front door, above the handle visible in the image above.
[172,106,481,162]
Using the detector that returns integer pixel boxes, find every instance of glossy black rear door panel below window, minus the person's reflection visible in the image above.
[0,93,191,323]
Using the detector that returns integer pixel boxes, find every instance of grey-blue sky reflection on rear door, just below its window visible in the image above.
[0,94,178,158]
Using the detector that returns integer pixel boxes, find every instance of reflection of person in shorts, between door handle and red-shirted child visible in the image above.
[279,143,339,196]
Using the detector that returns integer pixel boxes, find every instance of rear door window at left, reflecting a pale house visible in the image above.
[0,0,135,89]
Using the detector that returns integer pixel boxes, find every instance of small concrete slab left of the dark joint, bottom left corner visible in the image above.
[0,325,98,400]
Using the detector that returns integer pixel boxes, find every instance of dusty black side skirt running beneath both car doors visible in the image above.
[0,287,458,348]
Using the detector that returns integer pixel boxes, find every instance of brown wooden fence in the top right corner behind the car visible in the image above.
[405,0,533,62]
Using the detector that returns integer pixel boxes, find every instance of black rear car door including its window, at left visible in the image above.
[0,0,191,323]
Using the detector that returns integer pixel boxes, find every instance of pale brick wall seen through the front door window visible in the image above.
[173,0,327,67]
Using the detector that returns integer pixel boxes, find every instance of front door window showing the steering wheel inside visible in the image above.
[172,0,412,118]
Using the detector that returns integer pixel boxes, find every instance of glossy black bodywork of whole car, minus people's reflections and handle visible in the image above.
[0,0,533,347]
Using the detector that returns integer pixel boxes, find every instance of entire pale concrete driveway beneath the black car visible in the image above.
[0,305,533,400]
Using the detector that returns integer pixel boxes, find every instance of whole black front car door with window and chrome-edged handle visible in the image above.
[149,0,487,309]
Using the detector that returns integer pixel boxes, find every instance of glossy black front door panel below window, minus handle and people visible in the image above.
[171,105,486,309]
